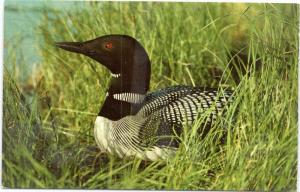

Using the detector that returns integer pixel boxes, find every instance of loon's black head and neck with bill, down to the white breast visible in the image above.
[56,35,151,120]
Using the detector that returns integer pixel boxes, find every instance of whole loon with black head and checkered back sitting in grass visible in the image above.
[56,35,232,161]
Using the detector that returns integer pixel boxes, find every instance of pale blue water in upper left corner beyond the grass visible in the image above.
[4,0,78,77]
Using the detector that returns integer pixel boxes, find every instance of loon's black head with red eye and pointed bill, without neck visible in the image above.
[56,35,150,78]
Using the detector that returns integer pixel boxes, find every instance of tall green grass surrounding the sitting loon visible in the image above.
[3,2,299,190]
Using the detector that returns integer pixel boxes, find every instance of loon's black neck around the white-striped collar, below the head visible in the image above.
[98,52,151,121]
